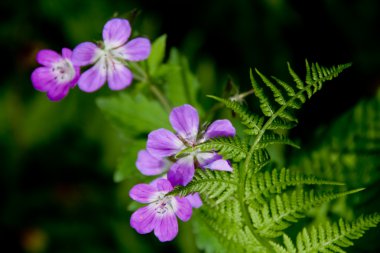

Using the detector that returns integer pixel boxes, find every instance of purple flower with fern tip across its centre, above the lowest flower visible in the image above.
[147,105,235,185]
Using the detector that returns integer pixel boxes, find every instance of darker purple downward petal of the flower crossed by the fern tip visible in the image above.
[168,156,195,186]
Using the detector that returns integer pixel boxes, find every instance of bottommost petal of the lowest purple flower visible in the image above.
[154,212,178,242]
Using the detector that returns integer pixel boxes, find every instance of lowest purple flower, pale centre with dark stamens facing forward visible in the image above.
[129,179,192,242]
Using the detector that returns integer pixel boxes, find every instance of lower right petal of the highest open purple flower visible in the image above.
[107,59,132,90]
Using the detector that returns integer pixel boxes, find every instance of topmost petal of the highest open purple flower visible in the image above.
[103,18,131,49]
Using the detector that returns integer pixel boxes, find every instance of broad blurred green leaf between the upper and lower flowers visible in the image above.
[96,93,171,137]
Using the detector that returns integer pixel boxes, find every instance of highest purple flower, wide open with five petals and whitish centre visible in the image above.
[73,18,151,92]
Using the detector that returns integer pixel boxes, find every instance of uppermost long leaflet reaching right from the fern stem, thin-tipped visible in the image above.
[245,168,344,201]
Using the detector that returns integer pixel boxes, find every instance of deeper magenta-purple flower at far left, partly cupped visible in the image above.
[31,48,80,101]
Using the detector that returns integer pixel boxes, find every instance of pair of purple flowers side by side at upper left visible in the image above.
[31,18,151,101]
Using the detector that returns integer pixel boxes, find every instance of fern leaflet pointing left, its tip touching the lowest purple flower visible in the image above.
[168,169,237,204]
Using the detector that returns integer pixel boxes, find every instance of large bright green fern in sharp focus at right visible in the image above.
[171,61,379,252]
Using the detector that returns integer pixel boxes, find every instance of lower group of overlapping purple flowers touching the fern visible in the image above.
[129,104,235,241]
